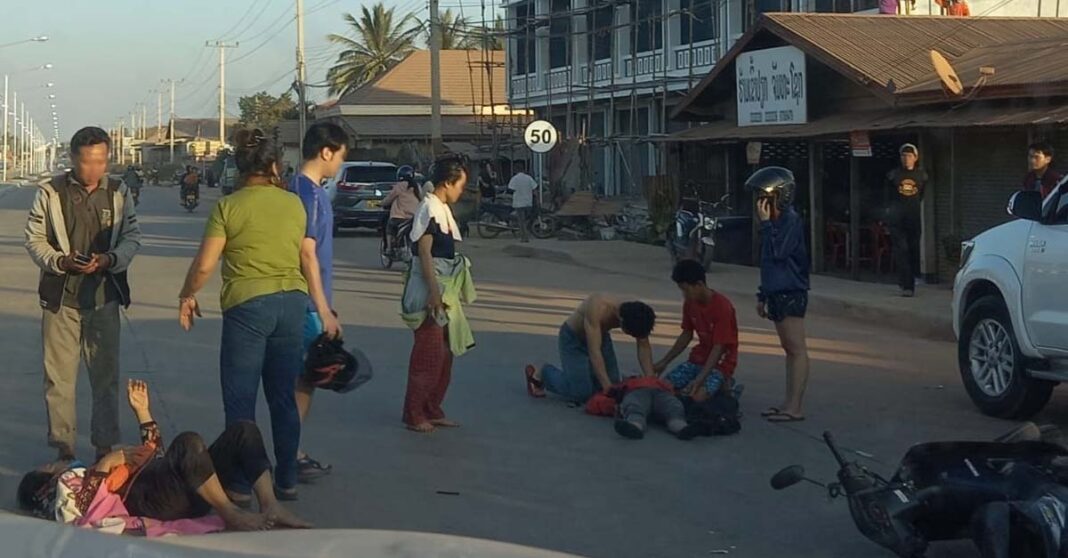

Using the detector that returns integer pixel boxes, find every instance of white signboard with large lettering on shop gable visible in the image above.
[735,46,808,126]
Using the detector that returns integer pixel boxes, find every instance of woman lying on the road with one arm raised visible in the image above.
[18,379,311,534]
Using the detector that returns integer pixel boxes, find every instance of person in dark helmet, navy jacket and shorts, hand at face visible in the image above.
[745,167,808,422]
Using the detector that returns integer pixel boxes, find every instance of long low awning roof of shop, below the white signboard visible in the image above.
[672,105,1068,141]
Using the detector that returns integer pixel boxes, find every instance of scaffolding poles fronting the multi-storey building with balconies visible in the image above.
[493,0,725,198]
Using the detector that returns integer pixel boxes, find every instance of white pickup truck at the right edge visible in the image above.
[953,177,1068,419]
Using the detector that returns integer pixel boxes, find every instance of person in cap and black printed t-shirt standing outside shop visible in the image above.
[886,143,927,297]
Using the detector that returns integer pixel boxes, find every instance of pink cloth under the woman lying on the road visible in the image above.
[74,486,225,537]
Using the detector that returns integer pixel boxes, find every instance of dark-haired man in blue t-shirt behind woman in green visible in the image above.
[289,123,348,482]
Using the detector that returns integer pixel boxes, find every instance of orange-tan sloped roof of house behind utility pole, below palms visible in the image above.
[337,50,508,107]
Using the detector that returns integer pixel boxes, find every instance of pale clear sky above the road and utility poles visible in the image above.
[0,0,494,141]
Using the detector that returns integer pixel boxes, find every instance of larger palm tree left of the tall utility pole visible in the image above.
[327,2,419,96]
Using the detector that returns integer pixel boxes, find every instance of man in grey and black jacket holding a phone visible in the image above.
[26,127,141,461]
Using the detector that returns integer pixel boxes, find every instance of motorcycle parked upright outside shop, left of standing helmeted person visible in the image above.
[665,185,731,268]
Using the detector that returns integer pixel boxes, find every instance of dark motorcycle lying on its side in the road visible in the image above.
[771,423,1068,558]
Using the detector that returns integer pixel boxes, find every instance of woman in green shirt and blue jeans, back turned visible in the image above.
[178,129,308,499]
